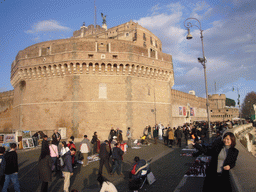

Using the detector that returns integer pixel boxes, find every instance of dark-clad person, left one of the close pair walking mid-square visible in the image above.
[98,140,111,175]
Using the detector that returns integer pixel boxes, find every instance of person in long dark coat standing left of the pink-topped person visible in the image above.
[38,140,52,192]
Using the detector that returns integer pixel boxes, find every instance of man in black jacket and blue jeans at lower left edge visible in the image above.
[2,143,20,192]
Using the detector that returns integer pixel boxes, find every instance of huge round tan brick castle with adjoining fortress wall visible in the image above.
[0,16,238,140]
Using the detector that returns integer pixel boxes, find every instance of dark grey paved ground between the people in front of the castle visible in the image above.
[9,141,203,192]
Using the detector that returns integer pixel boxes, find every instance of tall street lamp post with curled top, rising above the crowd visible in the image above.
[184,18,212,143]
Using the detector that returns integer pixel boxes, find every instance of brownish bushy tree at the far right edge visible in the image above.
[241,91,256,119]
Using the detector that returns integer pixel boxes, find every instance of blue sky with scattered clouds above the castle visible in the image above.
[0,0,256,106]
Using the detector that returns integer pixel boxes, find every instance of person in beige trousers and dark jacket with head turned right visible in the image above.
[62,148,76,192]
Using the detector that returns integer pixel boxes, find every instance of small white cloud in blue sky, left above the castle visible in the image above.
[25,20,70,34]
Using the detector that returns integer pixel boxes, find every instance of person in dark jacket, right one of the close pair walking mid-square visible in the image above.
[111,143,124,175]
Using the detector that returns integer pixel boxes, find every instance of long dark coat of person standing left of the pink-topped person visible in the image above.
[38,155,52,182]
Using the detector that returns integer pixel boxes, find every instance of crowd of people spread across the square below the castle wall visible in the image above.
[0,121,245,192]
